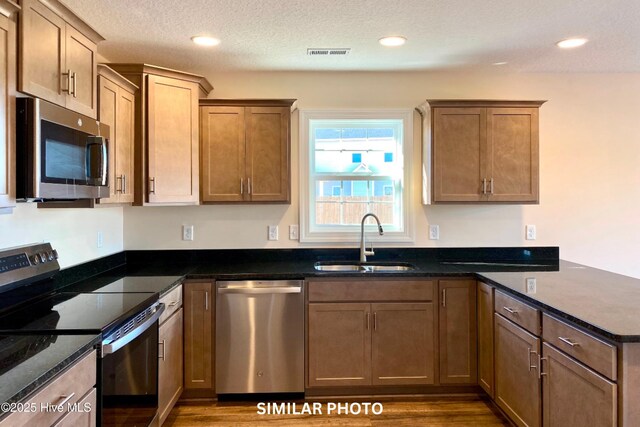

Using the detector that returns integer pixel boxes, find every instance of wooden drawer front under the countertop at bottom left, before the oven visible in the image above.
[0,350,97,427]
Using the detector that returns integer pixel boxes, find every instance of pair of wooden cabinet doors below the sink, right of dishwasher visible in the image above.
[307,302,435,387]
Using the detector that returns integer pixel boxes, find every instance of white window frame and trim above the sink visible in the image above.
[299,109,415,243]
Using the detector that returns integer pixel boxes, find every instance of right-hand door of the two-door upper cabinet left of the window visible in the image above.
[246,107,291,202]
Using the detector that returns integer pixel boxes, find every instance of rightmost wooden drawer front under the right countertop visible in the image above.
[542,314,617,381]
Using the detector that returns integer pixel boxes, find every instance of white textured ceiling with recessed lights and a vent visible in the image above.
[62,0,640,73]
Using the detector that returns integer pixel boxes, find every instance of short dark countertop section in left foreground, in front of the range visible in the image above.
[0,335,100,403]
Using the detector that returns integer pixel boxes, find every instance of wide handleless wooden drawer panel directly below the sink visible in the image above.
[308,278,435,302]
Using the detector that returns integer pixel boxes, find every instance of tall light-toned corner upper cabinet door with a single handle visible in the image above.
[147,75,199,204]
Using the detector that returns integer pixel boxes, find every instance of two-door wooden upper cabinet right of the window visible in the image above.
[427,100,545,203]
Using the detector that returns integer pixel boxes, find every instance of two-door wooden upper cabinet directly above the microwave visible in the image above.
[18,0,104,117]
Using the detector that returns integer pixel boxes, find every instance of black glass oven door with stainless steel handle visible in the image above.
[98,304,164,427]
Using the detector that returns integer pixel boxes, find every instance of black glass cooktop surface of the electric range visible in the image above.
[0,293,158,334]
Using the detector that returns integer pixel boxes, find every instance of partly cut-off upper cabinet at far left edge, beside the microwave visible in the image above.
[0,0,19,213]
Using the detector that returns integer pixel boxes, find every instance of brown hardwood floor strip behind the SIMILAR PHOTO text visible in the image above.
[164,396,510,427]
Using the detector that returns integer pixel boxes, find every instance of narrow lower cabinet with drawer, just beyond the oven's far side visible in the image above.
[158,286,184,425]
